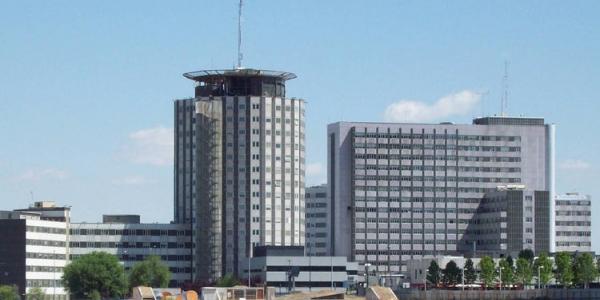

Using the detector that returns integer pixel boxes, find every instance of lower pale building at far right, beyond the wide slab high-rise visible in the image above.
[555,193,592,252]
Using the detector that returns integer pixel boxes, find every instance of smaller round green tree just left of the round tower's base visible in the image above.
[129,255,171,288]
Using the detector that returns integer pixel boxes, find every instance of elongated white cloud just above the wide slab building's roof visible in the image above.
[383,90,481,122]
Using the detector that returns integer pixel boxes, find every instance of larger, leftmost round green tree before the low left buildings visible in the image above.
[62,252,126,299]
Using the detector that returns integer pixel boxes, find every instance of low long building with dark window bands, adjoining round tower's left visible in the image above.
[70,216,193,287]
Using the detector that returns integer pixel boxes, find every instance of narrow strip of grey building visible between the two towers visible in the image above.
[304,184,331,256]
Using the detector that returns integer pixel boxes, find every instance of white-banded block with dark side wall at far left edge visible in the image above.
[0,211,68,300]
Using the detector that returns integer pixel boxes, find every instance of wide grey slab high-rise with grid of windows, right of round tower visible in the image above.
[328,117,555,272]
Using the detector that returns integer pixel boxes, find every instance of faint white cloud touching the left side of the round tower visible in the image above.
[124,126,174,166]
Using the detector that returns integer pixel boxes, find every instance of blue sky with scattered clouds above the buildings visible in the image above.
[0,0,600,250]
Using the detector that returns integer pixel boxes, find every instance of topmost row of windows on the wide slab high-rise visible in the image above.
[354,131,521,142]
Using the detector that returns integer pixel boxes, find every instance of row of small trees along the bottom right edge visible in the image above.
[426,249,600,288]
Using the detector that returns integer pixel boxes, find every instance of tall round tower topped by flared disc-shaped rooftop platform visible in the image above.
[174,69,305,281]
